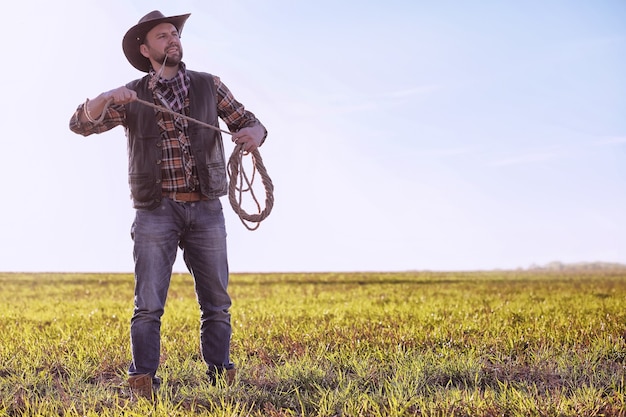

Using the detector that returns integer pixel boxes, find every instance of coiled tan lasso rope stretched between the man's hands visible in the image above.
[85,99,274,230]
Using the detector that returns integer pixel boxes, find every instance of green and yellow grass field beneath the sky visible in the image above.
[0,271,626,417]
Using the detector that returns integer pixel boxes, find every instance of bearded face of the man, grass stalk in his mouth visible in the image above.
[139,23,183,67]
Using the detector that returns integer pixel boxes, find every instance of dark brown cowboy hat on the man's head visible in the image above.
[122,10,191,72]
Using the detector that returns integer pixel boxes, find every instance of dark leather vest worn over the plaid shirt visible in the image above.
[126,70,228,209]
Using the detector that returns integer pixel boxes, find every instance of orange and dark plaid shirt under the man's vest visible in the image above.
[70,65,259,192]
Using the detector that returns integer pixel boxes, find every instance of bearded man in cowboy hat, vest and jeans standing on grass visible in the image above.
[70,10,267,398]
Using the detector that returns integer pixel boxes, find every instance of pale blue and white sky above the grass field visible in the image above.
[0,0,626,272]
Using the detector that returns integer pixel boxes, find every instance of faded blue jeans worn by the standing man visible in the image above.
[128,198,234,378]
